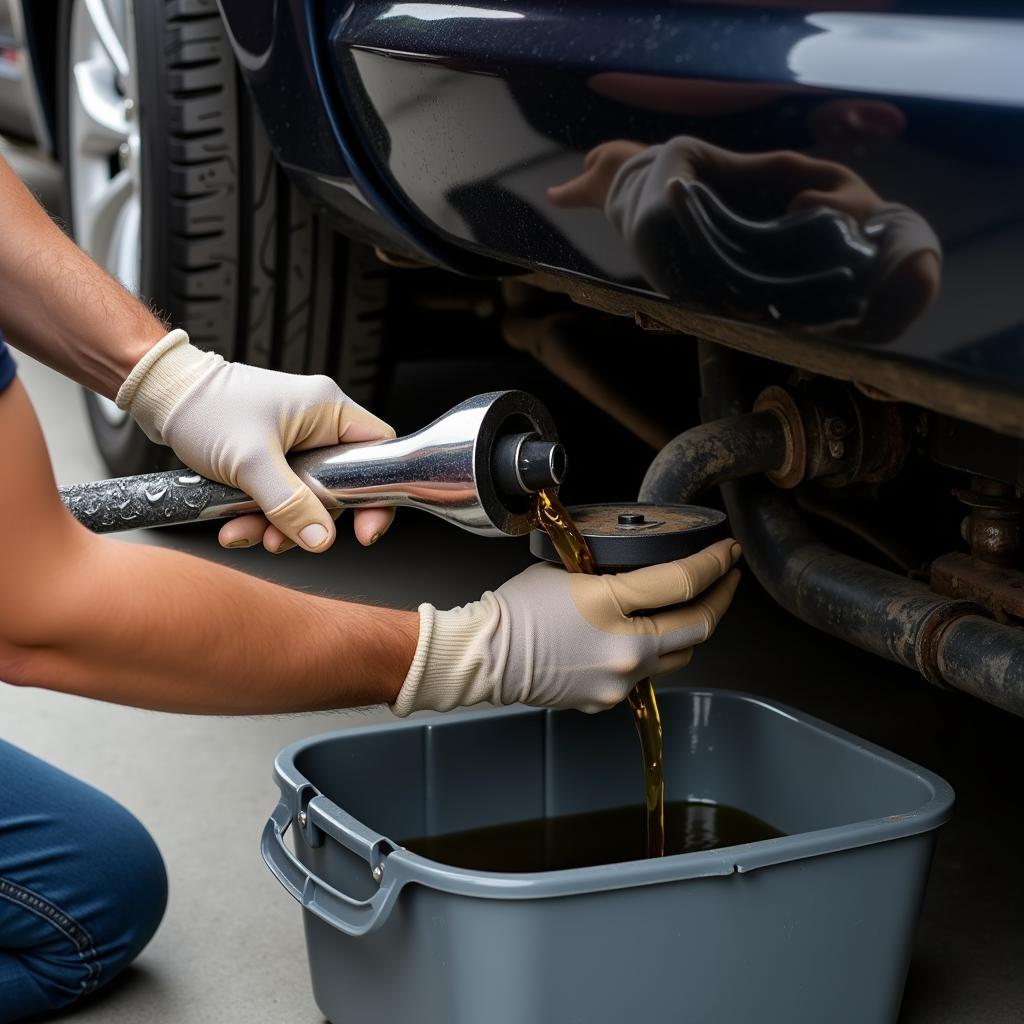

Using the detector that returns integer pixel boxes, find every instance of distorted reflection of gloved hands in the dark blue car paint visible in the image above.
[548,136,941,342]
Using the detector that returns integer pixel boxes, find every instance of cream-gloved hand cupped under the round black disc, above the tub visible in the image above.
[392,540,740,716]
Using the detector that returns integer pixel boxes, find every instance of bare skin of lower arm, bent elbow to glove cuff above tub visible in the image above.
[0,380,419,714]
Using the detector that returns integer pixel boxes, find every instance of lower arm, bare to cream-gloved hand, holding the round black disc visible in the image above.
[0,381,739,715]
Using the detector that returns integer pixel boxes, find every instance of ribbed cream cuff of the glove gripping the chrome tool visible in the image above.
[115,328,223,444]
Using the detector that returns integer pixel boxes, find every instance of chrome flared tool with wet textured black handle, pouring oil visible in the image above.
[60,391,565,537]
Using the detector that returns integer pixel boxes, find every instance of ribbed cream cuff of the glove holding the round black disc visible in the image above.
[391,593,502,718]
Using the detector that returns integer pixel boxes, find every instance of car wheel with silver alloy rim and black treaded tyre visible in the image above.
[59,0,388,474]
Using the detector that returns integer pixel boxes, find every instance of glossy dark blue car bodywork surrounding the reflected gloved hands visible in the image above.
[207,0,1024,391]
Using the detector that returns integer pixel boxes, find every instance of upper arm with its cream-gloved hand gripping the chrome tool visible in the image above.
[0,152,394,553]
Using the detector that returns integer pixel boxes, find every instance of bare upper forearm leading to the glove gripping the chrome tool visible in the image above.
[0,159,167,398]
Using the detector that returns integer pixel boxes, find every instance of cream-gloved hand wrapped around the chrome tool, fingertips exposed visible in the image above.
[117,331,394,554]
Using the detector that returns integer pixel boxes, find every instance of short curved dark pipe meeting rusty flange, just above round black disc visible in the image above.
[640,413,786,505]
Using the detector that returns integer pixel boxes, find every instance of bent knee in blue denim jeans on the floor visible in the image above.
[0,740,167,1024]
